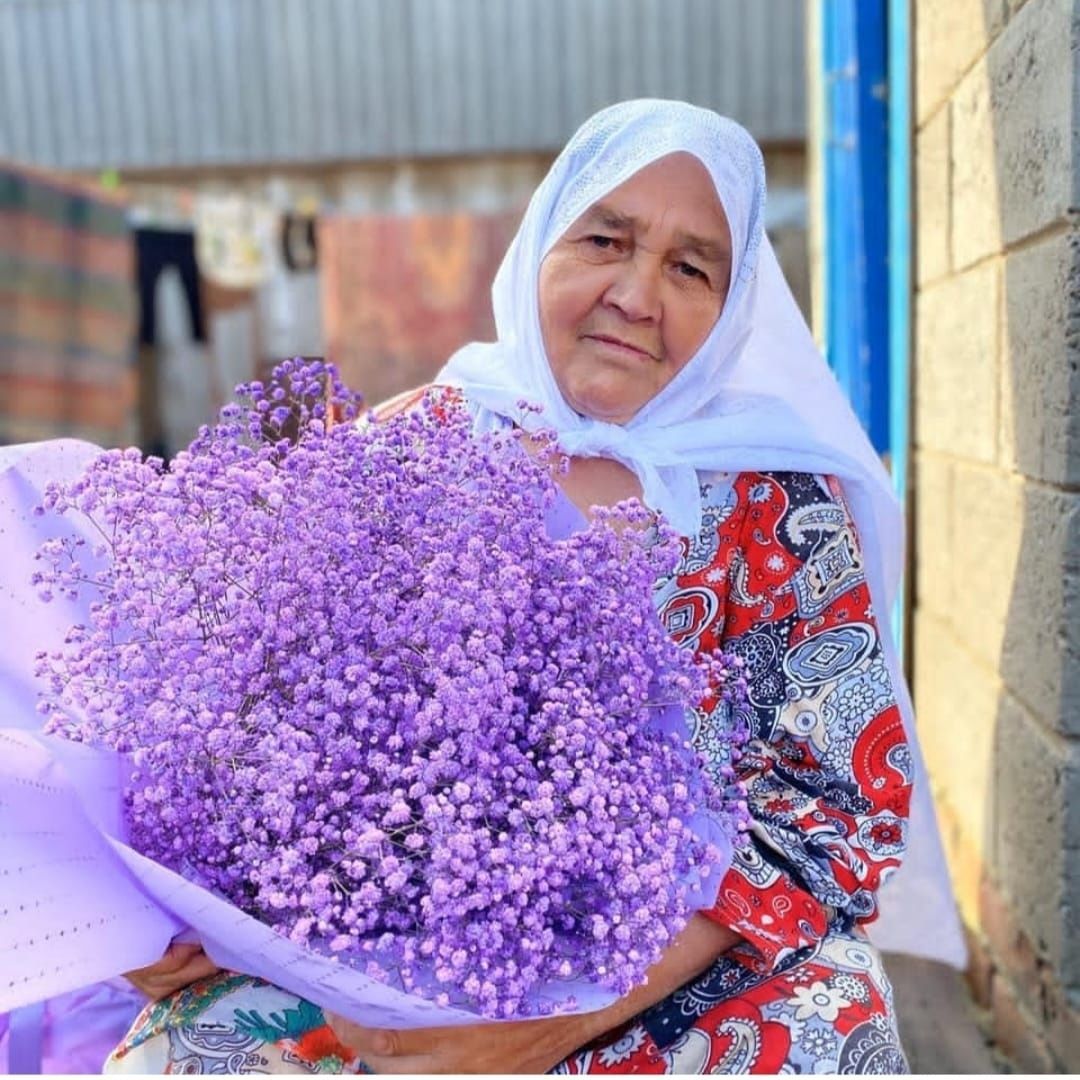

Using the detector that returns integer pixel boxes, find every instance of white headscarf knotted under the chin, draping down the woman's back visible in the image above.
[436,99,964,966]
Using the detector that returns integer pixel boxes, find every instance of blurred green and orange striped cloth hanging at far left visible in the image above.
[0,162,137,446]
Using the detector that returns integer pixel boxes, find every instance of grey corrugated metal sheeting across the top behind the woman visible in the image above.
[0,0,806,170]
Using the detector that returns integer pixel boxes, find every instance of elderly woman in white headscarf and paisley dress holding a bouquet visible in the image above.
[109,102,956,1072]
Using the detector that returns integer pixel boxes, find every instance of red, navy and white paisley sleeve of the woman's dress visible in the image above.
[661,472,913,972]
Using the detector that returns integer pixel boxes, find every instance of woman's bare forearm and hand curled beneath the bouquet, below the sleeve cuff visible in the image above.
[326,915,741,1074]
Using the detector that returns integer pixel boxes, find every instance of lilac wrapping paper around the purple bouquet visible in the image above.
[0,440,730,1028]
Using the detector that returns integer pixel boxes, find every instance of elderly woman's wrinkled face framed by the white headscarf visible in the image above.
[539,153,731,423]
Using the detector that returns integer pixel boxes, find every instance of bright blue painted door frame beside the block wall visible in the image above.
[818,0,912,654]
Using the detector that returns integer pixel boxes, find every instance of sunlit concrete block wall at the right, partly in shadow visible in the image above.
[913,0,1080,1071]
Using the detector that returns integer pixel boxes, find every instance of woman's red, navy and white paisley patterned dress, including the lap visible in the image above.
[106,472,912,1074]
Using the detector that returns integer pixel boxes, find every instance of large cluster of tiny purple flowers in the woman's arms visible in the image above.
[29,361,745,1016]
